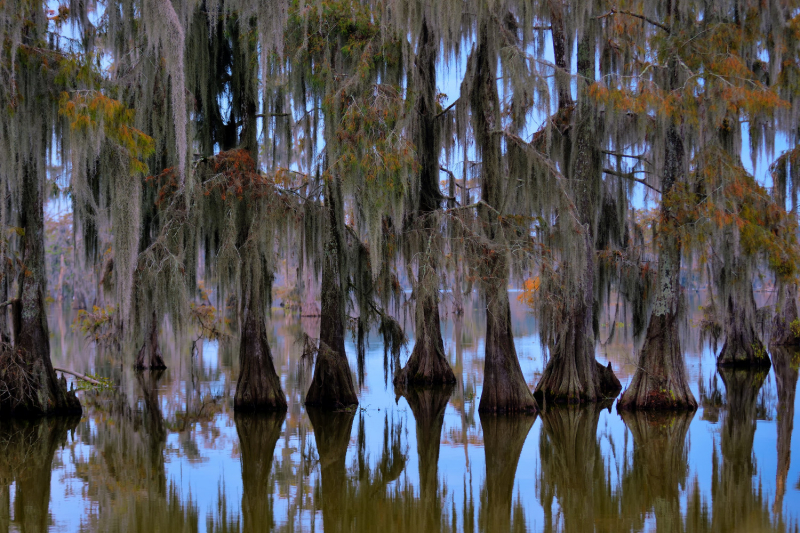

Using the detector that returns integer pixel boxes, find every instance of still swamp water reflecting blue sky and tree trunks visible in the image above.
[0,294,800,533]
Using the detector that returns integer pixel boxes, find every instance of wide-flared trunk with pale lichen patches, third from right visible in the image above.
[617,124,697,411]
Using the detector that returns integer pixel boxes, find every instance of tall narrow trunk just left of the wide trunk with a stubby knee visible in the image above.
[469,20,536,413]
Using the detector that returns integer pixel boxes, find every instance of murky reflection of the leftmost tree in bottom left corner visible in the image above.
[0,418,79,532]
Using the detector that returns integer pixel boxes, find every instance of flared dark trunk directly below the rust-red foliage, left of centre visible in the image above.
[233,260,287,411]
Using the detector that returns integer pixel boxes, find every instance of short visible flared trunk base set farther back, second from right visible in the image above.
[717,278,770,368]
